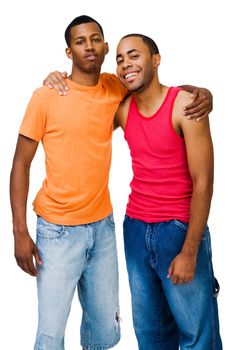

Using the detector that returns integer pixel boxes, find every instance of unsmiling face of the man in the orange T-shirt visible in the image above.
[66,22,108,73]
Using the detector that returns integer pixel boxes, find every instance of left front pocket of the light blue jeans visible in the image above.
[36,217,65,239]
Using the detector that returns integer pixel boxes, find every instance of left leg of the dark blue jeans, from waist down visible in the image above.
[124,217,179,350]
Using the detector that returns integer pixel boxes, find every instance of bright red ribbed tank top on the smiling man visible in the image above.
[124,87,192,222]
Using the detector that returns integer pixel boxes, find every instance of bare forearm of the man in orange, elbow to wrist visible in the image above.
[10,162,29,236]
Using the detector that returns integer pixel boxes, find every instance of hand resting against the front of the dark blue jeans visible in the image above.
[167,252,196,284]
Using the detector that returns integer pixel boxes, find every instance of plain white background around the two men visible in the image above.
[0,0,236,350]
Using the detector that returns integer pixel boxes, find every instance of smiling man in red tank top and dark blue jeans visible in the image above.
[116,34,222,350]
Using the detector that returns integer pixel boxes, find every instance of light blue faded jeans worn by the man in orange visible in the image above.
[34,214,120,350]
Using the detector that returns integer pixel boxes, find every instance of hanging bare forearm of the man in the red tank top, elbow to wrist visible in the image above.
[182,179,213,255]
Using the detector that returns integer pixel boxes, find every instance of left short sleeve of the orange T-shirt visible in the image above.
[19,91,47,142]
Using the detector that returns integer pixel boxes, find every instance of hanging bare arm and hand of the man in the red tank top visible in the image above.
[169,92,213,284]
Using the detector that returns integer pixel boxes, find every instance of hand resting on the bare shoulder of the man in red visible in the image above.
[184,88,213,121]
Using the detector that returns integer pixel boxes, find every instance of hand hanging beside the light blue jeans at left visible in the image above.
[15,235,42,276]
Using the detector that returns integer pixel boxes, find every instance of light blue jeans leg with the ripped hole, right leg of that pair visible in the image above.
[78,215,120,348]
